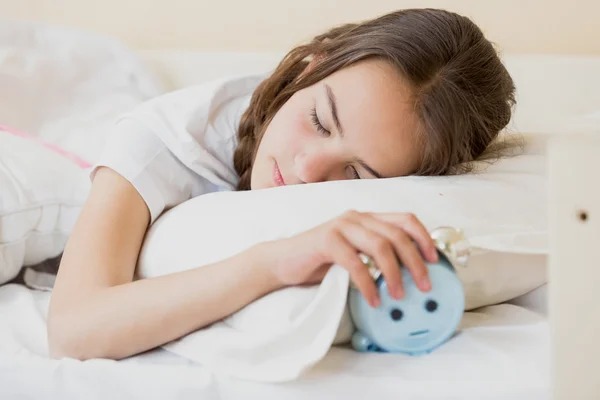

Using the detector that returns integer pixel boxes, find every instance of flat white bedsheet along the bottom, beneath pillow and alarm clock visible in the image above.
[0,284,549,400]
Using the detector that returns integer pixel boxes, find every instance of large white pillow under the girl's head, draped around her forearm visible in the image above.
[137,134,547,381]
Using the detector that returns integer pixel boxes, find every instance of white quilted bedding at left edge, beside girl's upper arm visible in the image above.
[0,128,90,284]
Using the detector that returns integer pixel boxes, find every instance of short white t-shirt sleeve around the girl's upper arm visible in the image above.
[90,117,218,223]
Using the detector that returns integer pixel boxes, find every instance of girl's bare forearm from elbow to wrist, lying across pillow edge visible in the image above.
[49,242,279,359]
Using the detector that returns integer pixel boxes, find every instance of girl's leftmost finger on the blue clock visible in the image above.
[328,230,380,307]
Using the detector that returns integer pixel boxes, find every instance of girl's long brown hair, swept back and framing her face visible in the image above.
[234,9,515,190]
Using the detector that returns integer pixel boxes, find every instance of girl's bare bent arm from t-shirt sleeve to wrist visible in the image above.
[48,168,279,359]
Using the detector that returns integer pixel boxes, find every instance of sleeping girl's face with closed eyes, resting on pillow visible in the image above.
[251,60,421,189]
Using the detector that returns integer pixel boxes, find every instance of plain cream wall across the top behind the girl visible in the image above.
[0,0,600,54]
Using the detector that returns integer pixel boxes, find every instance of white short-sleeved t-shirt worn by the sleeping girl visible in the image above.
[91,75,265,223]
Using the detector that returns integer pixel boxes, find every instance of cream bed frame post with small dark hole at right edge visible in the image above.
[548,133,600,400]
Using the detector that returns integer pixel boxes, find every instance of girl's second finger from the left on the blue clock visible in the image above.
[336,217,406,299]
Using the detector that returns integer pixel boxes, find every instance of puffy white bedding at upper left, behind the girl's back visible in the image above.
[0,18,163,163]
